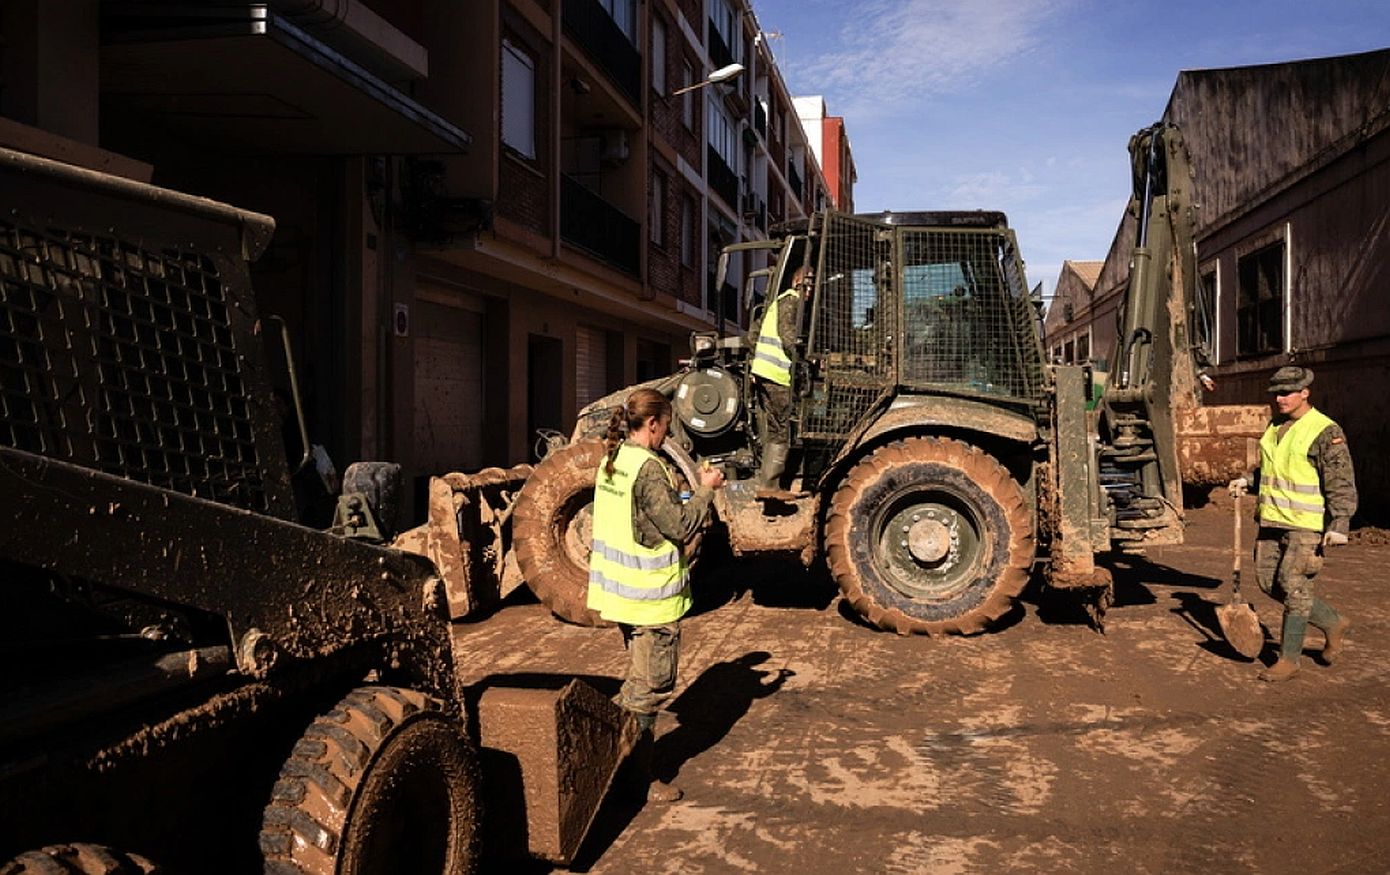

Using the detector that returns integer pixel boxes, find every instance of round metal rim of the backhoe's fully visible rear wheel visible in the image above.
[872,485,988,601]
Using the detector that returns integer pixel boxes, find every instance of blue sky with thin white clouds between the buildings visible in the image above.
[752,0,1390,294]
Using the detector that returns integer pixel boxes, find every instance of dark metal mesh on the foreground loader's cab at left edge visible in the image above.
[0,220,268,512]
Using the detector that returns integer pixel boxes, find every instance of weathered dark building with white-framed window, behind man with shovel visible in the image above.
[1048,50,1390,512]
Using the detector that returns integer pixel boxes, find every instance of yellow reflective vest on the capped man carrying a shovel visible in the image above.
[1259,409,1332,531]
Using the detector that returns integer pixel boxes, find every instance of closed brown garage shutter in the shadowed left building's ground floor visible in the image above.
[410,298,485,474]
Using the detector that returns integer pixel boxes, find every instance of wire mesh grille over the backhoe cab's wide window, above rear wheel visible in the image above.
[899,228,1043,398]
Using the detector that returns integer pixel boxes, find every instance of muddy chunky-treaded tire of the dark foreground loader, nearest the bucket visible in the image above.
[260,687,481,875]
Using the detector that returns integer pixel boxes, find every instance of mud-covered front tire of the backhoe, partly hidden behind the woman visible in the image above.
[512,441,607,626]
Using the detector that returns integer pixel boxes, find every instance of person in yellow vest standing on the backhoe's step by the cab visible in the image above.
[752,264,812,501]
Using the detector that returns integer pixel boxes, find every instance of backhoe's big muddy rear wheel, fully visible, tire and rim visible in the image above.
[826,438,1034,634]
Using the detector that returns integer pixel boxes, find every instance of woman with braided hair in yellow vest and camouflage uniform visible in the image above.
[588,390,724,801]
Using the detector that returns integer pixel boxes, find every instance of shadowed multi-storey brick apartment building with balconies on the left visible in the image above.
[0,0,845,517]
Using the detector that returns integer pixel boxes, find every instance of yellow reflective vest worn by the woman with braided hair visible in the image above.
[588,444,691,626]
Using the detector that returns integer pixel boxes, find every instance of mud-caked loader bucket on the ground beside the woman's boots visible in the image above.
[478,680,638,865]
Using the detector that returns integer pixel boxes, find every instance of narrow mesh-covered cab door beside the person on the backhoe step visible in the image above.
[801,213,895,441]
